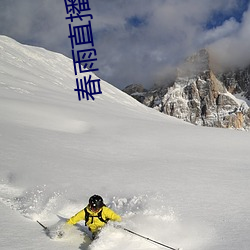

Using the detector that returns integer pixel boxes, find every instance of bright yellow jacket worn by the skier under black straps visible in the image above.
[67,206,122,233]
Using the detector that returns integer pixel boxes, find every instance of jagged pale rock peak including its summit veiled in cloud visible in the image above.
[161,50,250,129]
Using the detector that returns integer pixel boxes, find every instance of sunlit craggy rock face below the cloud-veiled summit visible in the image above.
[161,73,249,129]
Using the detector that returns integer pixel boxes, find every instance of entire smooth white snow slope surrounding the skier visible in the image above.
[0,36,250,250]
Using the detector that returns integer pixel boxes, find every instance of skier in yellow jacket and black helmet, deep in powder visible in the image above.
[67,195,122,239]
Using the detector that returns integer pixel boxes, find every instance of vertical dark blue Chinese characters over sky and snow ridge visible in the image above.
[64,0,102,101]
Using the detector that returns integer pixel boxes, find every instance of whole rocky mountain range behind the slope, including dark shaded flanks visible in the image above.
[124,49,250,129]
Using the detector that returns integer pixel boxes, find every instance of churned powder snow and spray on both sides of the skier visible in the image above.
[0,180,213,250]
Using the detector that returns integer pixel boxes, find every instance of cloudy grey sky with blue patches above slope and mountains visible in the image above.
[0,0,250,89]
